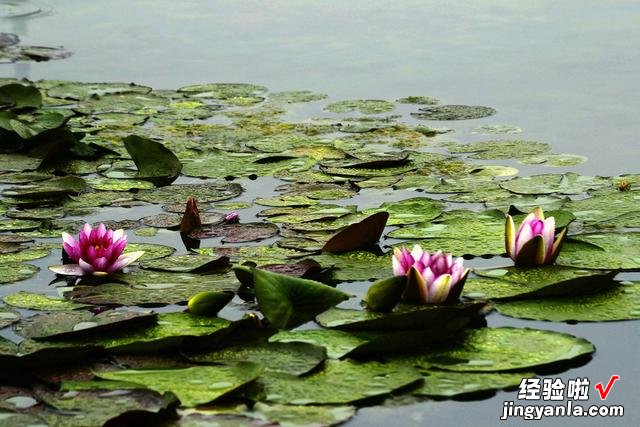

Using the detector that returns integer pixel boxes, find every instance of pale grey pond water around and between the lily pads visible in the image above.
[0,0,640,426]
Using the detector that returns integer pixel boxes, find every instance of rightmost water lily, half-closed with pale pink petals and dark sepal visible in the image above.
[505,207,567,266]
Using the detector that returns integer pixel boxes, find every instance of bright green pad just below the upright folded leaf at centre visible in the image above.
[269,329,368,359]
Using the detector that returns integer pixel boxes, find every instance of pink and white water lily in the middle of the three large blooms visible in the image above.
[392,245,469,304]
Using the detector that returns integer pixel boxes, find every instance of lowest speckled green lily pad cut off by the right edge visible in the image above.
[496,282,640,322]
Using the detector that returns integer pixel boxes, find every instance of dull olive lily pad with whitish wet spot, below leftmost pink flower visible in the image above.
[15,310,155,339]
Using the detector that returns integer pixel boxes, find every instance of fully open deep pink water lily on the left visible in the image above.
[49,224,144,276]
